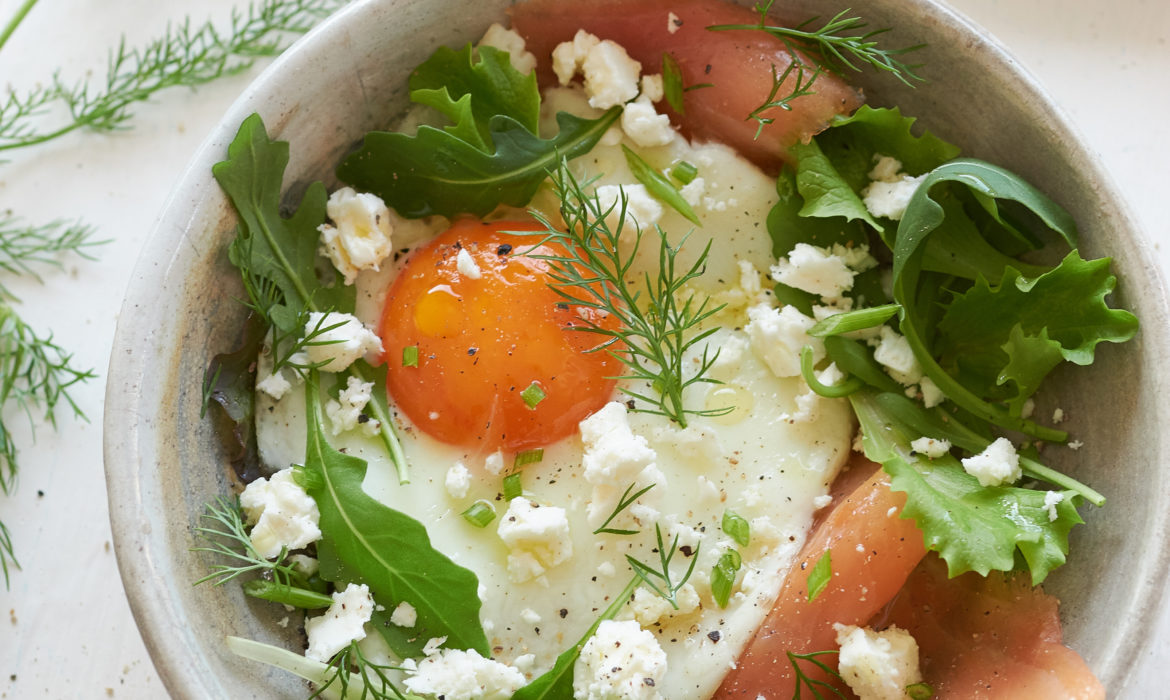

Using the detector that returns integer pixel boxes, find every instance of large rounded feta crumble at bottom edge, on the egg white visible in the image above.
[573,620,667,700]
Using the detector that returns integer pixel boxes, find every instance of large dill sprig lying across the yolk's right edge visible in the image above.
[531,160,732,427]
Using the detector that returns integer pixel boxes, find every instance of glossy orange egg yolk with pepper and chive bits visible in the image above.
[380,220,621,452]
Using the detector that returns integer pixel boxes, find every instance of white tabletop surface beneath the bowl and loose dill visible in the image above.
[0,0,1170,700]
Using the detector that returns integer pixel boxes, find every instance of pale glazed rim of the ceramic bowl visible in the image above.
[103,0,1170,698]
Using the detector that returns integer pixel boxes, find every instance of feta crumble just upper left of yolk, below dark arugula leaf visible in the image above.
[317,187,394,284]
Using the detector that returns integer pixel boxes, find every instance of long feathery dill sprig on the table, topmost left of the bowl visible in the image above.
[0,0,344,151]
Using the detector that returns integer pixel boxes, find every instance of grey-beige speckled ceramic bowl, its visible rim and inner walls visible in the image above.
[105,0,1170,698]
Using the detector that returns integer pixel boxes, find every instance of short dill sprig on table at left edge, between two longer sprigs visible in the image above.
[0,212,105,298]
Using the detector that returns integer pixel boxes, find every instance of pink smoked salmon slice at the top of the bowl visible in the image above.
[511,0,861,170]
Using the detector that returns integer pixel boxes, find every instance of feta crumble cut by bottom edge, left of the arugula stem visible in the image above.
[402,648,527,700]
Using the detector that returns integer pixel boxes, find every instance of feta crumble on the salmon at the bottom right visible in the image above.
[833,624,922,700]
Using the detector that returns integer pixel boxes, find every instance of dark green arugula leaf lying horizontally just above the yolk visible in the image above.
[337,107,621,218]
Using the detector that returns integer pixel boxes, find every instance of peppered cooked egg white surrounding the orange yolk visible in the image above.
[256,89,853,698]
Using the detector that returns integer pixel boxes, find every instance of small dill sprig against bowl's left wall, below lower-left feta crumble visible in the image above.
[191,496,304,586]
